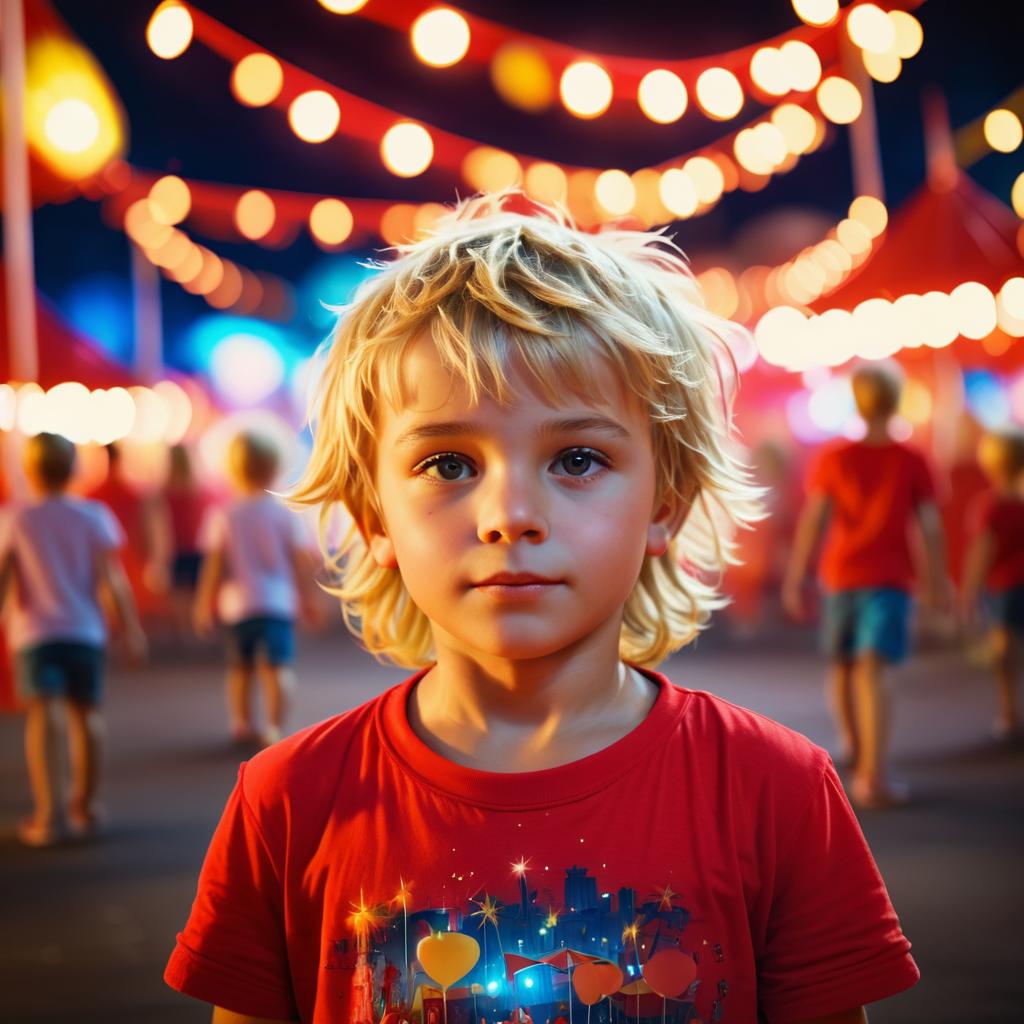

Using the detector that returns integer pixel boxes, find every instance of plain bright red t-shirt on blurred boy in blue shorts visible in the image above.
[807,441,935,591]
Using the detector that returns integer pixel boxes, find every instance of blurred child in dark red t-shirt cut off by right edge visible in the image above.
[961,429,1024,739]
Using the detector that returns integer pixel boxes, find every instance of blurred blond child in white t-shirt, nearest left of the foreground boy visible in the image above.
[195,433,316,743]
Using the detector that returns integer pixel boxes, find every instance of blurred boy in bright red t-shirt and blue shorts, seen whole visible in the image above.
[782,364,948,808]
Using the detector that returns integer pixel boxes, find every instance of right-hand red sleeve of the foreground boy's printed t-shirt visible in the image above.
[758,763,921,1024]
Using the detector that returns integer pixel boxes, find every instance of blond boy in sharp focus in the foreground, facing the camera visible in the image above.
[165,196,918,1024]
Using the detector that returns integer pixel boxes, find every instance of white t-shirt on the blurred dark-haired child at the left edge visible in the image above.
[0,495,125,650]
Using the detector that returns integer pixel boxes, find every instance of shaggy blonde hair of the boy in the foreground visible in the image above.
[291,191,760,667]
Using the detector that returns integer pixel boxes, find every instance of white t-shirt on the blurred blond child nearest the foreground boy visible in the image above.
[200,495,306,624]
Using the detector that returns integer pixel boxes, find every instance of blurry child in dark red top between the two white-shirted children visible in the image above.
[146,444,209,638]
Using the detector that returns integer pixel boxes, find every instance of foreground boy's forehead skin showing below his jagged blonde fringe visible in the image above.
[381,335,648,426]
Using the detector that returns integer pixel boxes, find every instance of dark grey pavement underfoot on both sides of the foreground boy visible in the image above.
[0,628,1024,1024]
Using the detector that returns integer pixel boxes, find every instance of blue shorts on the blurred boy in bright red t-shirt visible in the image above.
[821,587,913,665]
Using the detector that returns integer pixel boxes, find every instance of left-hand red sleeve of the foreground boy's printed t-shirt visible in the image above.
[164,765,298,1020]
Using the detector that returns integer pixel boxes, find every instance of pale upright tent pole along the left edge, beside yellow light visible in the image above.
[0,0,39,381]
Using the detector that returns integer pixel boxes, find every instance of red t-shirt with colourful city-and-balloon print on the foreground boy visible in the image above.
[165,673,919,1024]
